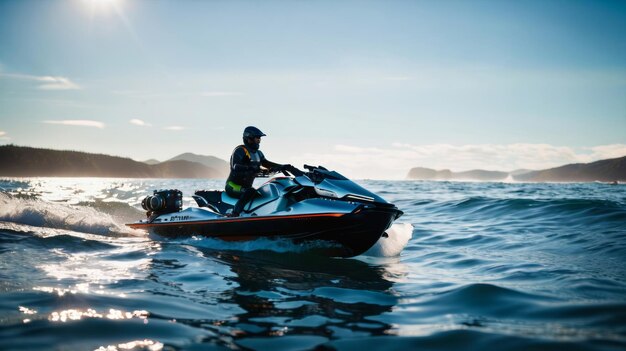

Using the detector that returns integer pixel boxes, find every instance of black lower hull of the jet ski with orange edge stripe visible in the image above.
[128,206,402,257]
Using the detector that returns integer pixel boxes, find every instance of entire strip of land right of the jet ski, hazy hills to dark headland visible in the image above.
[407,156,626,182]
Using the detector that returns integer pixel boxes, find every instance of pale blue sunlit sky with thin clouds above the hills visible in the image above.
[0,0,626,179]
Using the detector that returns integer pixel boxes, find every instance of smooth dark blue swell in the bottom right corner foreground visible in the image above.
[378,283,626,350]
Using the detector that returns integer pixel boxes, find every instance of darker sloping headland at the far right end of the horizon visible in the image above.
[514,156,626,182]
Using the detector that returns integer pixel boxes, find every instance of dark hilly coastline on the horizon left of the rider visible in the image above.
[0,145,228,179]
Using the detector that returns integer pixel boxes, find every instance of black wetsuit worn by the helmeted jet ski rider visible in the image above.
[225,145,281,216]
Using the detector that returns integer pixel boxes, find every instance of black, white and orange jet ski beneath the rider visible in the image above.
[127,165,403,257]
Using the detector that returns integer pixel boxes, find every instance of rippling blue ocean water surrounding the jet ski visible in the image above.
[0,178,626,351]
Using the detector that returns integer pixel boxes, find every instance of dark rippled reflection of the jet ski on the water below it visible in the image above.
[193,249,397,348]
